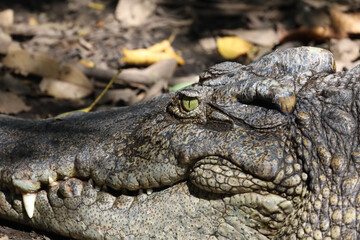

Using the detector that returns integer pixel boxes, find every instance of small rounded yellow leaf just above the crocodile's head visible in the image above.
[217,37,254,59]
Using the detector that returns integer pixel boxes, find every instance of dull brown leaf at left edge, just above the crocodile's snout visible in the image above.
[0,91,31,114]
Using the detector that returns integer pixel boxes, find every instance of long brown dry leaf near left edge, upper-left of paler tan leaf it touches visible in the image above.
[2,50,60,78]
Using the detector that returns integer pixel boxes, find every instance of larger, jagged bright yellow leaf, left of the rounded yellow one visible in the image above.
[121,40,185,65]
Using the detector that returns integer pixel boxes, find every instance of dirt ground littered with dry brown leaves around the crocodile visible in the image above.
[0,0,360,240]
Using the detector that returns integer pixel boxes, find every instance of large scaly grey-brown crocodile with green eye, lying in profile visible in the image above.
[0,47,360,239]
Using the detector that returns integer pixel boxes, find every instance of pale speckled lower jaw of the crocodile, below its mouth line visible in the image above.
[0,179,293,239]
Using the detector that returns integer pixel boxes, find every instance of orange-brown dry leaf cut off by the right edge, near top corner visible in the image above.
[330,9,360,34]
